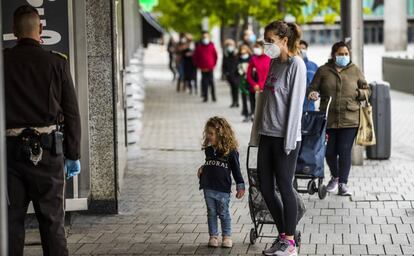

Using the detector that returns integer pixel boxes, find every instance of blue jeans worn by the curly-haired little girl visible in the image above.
[204,189,231,236]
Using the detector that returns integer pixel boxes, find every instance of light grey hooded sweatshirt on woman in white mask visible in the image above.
[259,56,306,155]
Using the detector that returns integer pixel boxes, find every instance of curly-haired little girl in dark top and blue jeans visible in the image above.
[197,116,245,248]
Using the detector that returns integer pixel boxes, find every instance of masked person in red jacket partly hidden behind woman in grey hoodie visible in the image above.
[247,41,270,120]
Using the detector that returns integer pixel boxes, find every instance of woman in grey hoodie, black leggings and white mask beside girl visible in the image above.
[257,21,306,256]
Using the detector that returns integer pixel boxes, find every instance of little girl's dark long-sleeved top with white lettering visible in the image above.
[200,146,244,193]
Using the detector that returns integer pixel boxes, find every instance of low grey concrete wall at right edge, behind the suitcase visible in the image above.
[382,57,414,94]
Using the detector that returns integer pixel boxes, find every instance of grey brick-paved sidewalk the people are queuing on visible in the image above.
[26,45,414,256]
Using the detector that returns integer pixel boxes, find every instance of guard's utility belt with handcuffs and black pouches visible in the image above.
[6,125,63,165]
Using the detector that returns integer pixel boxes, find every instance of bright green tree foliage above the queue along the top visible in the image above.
[154,0,340,35]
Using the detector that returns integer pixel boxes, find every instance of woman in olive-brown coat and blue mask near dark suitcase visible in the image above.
[308,42,370,196]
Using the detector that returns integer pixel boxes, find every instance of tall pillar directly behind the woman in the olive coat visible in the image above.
[341,0,364,165]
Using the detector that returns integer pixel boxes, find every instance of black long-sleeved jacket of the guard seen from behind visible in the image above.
[4,39,81,160]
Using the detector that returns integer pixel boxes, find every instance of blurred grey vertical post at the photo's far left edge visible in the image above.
[0,1,8,255]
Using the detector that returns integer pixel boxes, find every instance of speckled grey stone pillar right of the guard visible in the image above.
[86,0,125,213]
